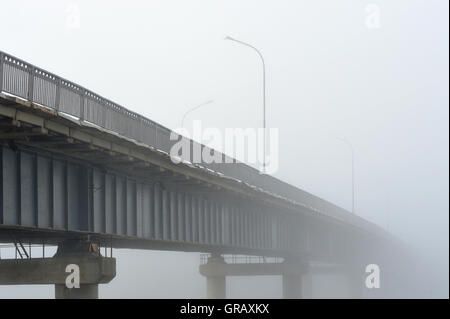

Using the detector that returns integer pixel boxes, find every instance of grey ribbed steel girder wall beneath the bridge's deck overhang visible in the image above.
[0,144,356,260]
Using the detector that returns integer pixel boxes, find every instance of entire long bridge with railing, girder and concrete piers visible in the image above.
[0,52,392,298]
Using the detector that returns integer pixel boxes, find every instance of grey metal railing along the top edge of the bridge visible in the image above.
[0,51,366,230]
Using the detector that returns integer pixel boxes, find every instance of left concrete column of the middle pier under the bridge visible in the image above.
[200,254,227,299]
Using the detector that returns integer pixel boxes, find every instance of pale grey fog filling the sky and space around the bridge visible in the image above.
[0,0,449,298]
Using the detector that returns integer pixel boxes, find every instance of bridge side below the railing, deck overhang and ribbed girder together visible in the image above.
[0,97,378,262]
